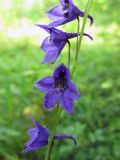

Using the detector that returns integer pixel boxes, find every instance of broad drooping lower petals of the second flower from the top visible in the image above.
[41,37,66,63]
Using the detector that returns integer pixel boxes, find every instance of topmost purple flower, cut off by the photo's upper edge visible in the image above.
[46,0,93,27]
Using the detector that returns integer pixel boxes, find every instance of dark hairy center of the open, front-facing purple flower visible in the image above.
[55,71,67,91]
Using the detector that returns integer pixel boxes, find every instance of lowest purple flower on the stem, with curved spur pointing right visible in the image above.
[22,119,76,153]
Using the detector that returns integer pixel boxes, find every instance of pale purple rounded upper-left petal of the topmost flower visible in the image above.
[46,5,65,20]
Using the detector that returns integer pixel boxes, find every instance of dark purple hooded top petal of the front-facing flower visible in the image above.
[53,64,70,81]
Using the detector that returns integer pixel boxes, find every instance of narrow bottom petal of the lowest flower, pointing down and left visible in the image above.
[22,142,48,153]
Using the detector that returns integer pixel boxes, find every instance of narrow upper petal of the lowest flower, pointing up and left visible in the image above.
[32,119,49,137]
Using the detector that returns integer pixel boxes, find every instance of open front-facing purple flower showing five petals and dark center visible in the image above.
[35,64,80,114]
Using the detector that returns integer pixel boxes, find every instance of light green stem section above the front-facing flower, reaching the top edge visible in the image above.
[71,0,92,77]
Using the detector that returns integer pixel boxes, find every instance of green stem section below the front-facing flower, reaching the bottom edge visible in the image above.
[45,104,62,160]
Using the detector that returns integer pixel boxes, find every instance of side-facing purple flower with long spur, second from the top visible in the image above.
[37,24,92,63]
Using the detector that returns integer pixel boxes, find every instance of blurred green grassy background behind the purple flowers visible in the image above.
[0,0,120,160]
